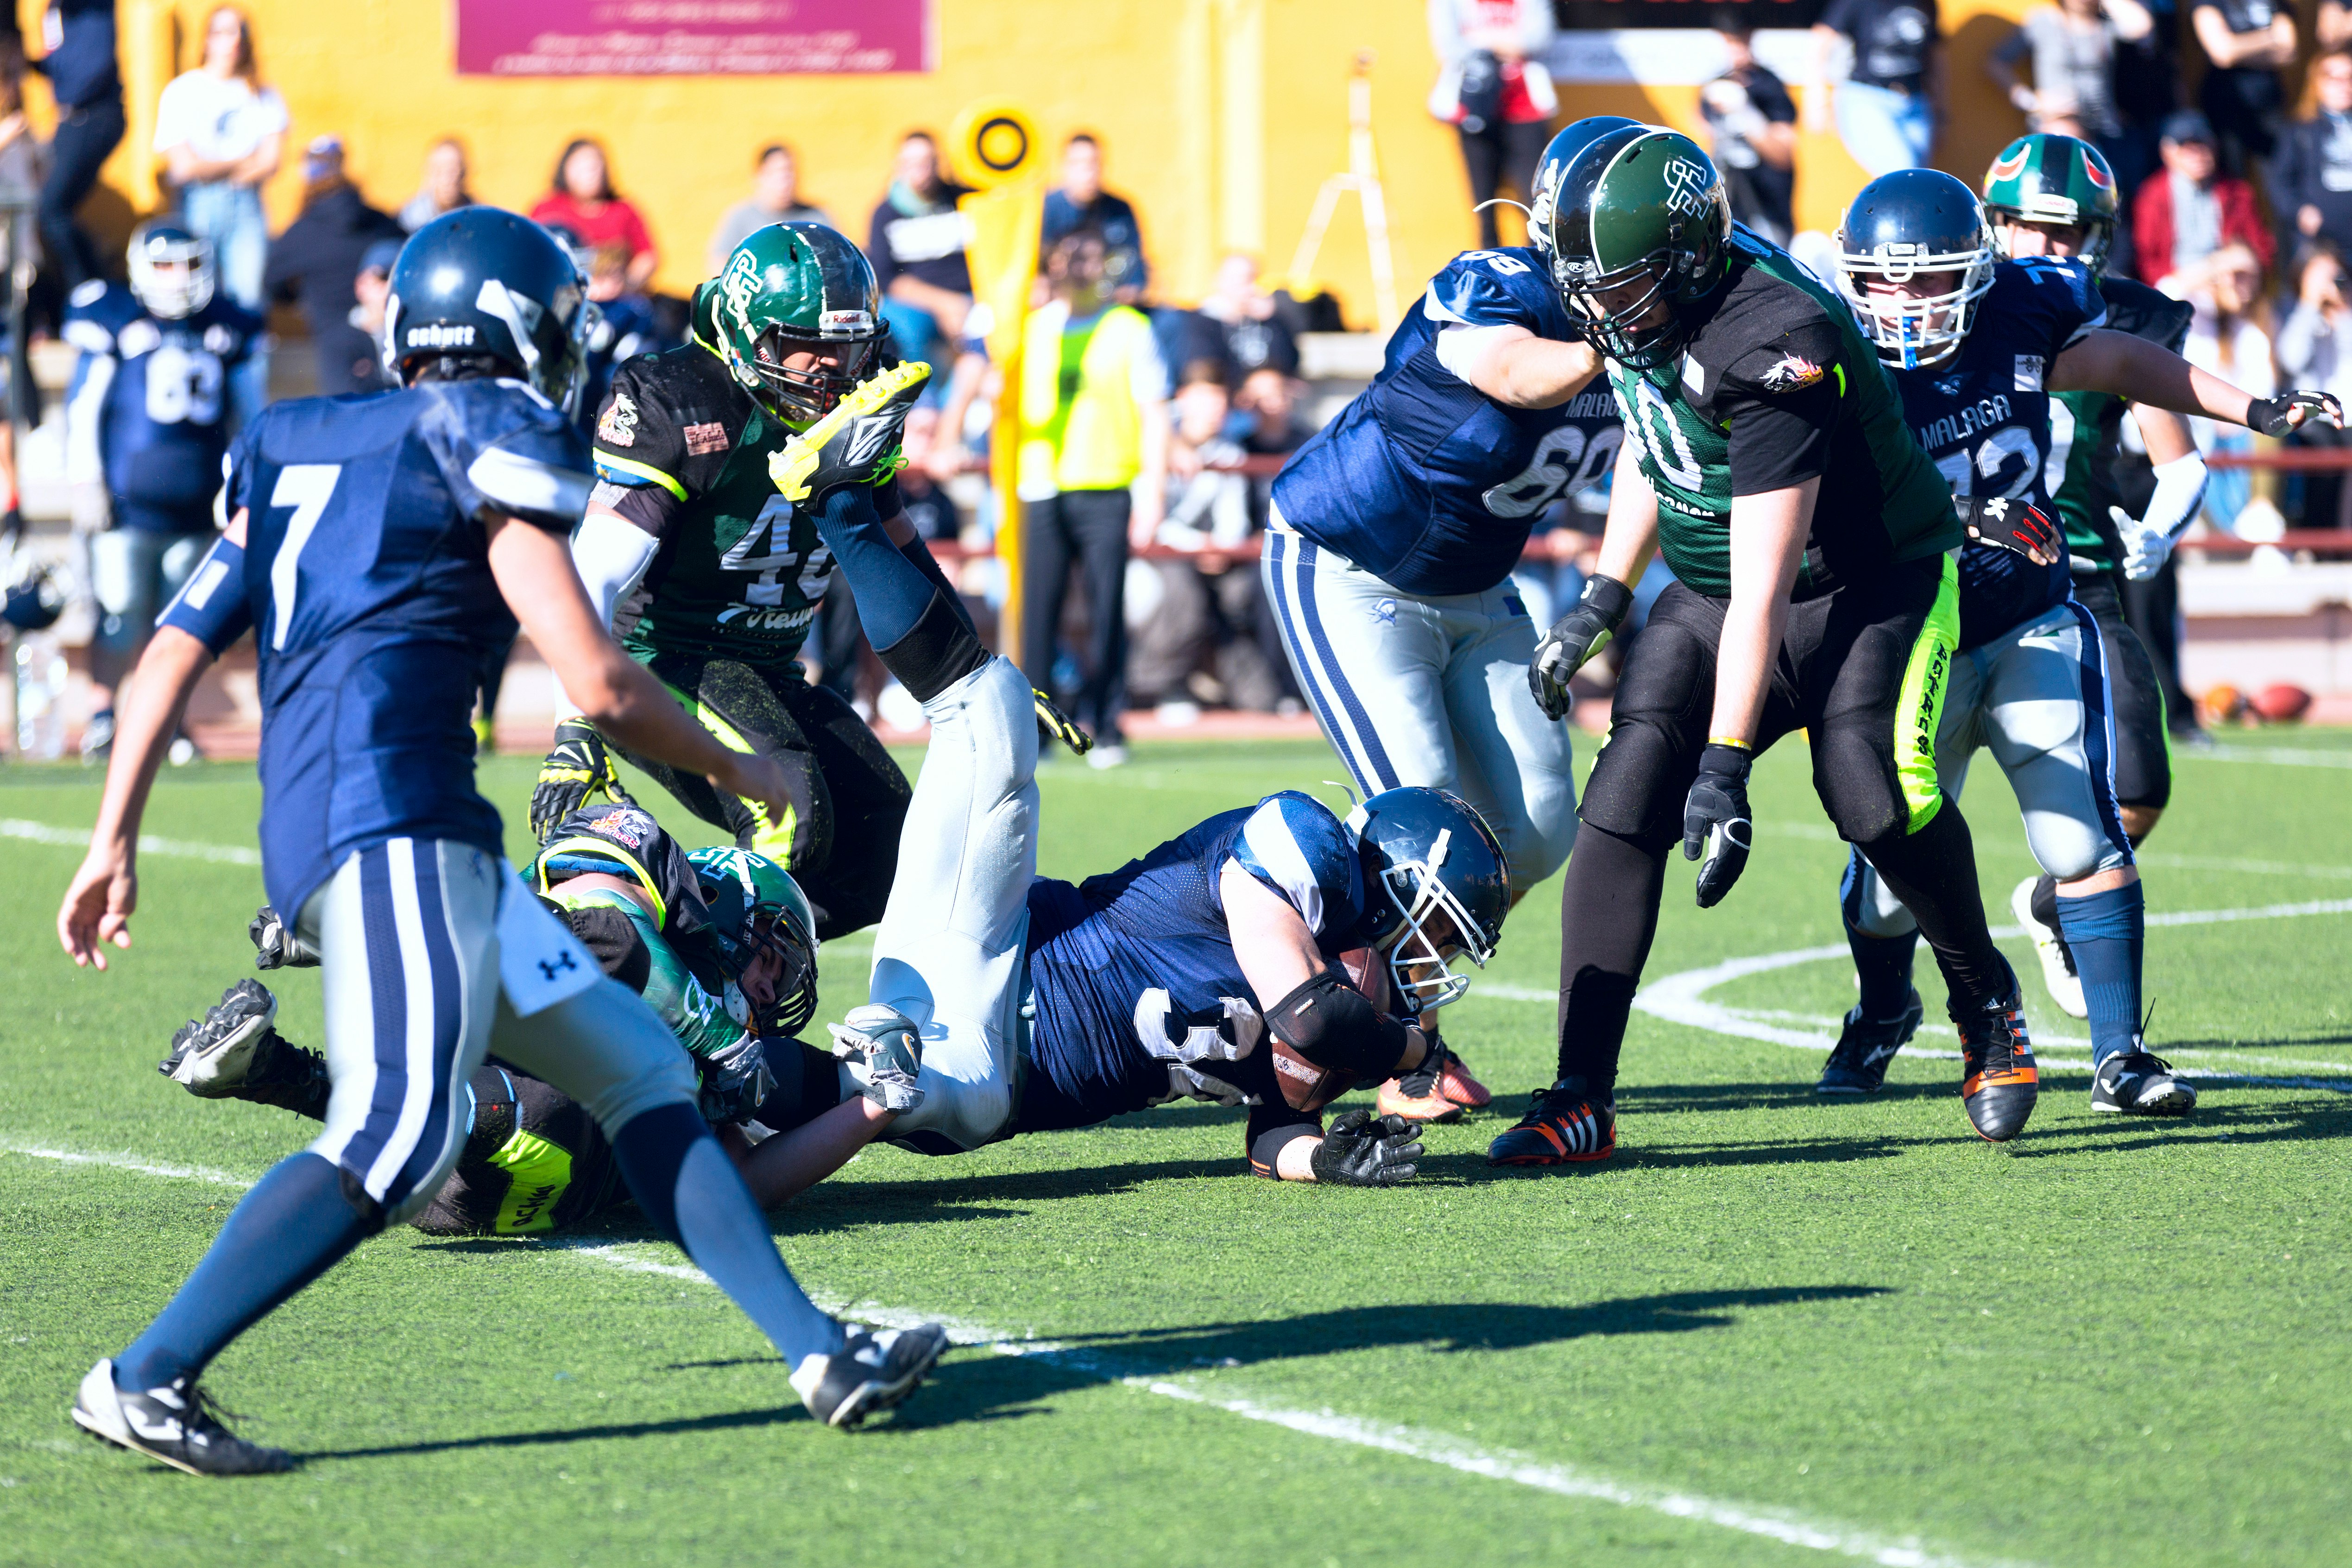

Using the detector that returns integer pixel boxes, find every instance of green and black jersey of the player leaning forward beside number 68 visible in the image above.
[1609,230,1961,597]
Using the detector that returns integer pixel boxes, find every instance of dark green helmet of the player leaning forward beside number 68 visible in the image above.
[1538,125,1731,369]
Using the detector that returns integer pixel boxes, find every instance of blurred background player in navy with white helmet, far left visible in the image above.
[63,223,261,757]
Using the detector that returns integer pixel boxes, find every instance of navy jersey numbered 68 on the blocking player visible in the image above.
[1275,247,1623,597]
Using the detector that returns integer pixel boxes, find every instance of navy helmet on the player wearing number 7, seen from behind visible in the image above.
[384,207,588,414]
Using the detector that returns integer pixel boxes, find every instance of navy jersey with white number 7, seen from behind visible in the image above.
[162,381,590,919]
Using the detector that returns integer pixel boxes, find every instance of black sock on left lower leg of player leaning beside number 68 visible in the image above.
[1559,823,1679,1100]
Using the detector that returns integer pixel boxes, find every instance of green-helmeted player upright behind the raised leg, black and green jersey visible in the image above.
[531,223,908,938]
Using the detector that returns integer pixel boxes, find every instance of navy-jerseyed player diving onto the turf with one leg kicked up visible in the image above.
[715,365,1510,1201]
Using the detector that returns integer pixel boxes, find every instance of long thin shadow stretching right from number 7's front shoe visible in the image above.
[891,1286,1889,1429]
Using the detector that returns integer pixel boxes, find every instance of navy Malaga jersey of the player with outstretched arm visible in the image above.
[1889,256,2107,649]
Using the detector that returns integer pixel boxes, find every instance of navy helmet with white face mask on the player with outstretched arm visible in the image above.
[1837,169,1999,369]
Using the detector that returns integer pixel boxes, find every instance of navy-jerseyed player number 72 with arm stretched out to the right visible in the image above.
[1821,169,2343,1117]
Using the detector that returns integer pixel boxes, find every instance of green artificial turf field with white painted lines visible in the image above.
[0,731,2352,1568]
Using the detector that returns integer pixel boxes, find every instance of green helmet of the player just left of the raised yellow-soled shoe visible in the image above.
[694,223,887,428]
